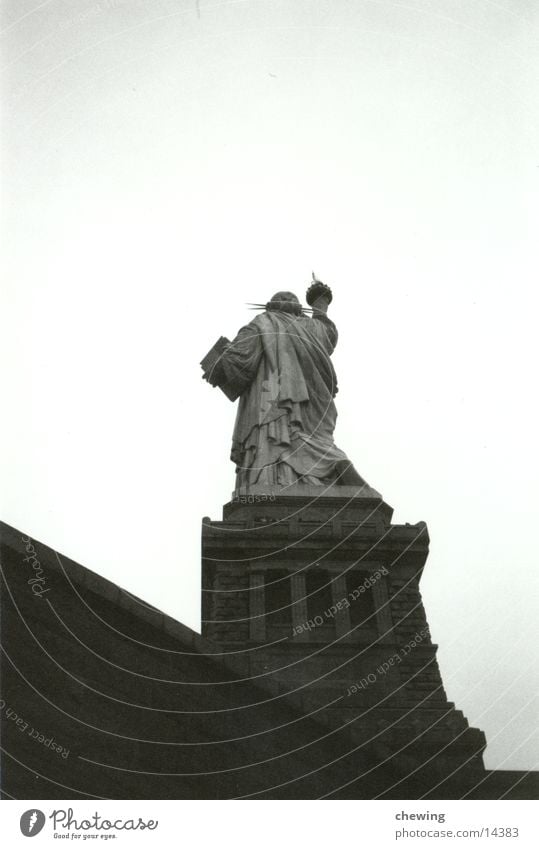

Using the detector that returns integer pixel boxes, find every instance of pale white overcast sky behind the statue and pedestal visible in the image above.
[0,0,539,768]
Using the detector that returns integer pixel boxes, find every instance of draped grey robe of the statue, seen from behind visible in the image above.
[220,311,364,489]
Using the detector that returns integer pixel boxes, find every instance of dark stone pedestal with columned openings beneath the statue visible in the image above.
[202,487,485,795]
